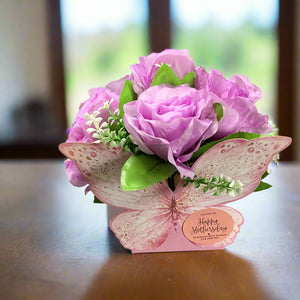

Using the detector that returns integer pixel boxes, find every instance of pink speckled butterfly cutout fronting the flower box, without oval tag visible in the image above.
[59,136,291,253]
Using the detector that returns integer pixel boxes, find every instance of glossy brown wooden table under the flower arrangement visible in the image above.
[0,161,300,300]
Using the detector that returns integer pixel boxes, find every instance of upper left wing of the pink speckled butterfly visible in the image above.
[59,143,172,210]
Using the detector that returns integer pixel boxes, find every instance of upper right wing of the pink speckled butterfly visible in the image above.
[175,136,291,214]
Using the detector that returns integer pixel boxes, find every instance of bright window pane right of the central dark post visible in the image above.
[171,0,278,122]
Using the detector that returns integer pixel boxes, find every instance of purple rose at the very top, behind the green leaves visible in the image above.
[130,49,195,94]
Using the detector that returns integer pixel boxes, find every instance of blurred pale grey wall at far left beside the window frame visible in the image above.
[0,0,50,142]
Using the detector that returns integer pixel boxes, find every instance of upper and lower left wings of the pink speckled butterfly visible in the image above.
[59,143,173,251]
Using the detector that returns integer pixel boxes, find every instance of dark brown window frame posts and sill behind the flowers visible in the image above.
[0,0,296,161]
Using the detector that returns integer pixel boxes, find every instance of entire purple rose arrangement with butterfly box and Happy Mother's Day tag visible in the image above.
[59,49,291,252]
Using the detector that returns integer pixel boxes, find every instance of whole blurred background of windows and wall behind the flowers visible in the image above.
[0,0,300,160]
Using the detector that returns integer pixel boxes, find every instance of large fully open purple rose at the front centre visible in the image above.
[124,85,218,177]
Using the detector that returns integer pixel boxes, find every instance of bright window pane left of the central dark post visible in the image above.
[61,0,149,126]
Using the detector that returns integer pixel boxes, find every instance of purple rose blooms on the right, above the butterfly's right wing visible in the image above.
[195,68,273,140]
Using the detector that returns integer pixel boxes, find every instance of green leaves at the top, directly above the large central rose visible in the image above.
[151,64,196,87]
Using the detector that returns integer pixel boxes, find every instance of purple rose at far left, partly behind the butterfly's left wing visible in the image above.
[65,88,119,186]
